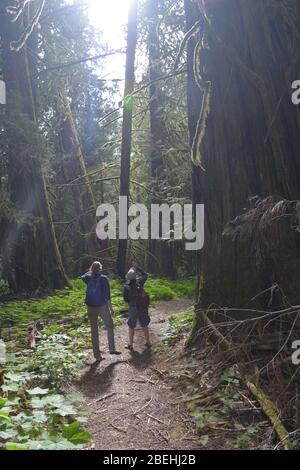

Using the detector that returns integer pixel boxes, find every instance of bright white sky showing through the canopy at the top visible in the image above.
[88,0,131,78]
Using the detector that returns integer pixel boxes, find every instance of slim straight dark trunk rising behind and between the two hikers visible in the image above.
[117,0,138,277]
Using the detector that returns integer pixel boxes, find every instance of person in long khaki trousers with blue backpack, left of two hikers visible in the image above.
[81,261,121,362]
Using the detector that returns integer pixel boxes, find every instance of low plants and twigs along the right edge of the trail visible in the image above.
[157,311,282,449]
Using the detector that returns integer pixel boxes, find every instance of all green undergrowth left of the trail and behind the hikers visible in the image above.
[0,279,195,450]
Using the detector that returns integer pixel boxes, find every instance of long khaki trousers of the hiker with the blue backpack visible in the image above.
[88,305,115,359]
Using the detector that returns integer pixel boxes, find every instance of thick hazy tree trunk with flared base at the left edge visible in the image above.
[0,1,68,292]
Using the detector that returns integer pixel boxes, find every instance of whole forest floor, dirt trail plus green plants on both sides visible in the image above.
[0,279,280,450]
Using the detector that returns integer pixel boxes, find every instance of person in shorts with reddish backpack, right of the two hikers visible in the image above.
[123,262,151,351]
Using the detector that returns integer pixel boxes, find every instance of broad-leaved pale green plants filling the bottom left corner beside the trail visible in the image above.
[0,335,91,450]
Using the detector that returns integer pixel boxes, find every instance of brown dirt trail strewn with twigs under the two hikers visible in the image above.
[78,299,199,450]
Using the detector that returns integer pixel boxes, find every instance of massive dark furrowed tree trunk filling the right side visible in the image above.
[185,0,300,307]
